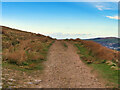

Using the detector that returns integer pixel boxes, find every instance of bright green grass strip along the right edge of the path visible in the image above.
[75,44,120,87]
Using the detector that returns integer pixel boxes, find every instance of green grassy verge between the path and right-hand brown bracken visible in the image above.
[74,43,118,87]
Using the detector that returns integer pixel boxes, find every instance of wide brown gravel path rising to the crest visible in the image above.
[41,41,104,88]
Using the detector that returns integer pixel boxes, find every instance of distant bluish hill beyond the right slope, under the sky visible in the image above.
[87,37,120,51]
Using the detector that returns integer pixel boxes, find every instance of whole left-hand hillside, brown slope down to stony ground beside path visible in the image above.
[2,26,55,88]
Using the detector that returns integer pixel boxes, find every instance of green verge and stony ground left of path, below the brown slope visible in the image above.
[2,41,54,88]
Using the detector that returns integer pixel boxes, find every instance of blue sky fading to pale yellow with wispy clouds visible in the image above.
[2,1,120,39]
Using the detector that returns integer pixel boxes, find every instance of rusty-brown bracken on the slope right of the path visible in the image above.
[69,38,120,63]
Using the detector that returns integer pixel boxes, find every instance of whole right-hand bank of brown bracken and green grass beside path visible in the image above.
[67,38,120,87]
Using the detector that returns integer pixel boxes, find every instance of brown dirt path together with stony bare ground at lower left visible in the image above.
[2,41,105,88]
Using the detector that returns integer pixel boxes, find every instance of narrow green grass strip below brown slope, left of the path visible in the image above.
[2,41,54,72]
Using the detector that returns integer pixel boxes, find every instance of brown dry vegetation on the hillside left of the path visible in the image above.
[2,26,53,65]
